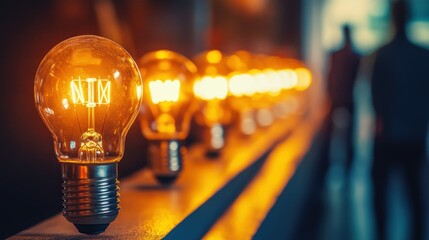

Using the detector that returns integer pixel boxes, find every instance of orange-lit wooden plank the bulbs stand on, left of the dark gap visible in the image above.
[16,116,298,239]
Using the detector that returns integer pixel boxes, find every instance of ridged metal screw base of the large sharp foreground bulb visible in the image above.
[61,163,119,235]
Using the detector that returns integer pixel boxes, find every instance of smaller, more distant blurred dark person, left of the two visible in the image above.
[328,25,361,171]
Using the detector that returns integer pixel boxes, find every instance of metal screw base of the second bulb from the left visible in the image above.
[149,140,186,185]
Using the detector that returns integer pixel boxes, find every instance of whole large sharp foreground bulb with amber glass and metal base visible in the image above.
[34,35,142,234]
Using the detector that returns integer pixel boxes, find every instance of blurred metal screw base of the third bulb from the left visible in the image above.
[203,124,225,158]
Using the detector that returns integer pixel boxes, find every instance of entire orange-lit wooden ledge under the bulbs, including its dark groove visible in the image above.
[11,104,321,239]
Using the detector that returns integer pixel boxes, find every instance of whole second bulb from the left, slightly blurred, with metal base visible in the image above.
[138,50,197,184]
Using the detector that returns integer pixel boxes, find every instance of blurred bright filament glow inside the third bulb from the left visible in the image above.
[194,76,228,101]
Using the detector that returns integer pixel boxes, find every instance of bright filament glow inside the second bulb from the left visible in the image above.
[149,79,180,104]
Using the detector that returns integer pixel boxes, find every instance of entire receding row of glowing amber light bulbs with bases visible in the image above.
[34,35,311,234]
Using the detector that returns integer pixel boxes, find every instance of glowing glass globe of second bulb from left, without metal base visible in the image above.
[139,50,198,140]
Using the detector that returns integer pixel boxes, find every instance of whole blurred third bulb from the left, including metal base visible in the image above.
[193,50,231,157]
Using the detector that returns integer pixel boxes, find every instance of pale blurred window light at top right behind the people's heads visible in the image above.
[322,0,429,54]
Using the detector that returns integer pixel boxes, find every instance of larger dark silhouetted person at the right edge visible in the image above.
[371,1,429,239]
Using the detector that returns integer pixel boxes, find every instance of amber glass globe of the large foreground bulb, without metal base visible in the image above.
[34,35,142,163]
